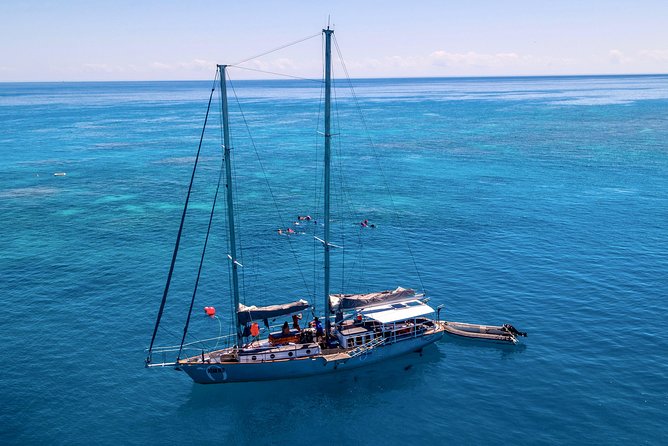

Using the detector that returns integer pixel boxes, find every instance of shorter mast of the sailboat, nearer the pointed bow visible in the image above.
[218,65,242,340]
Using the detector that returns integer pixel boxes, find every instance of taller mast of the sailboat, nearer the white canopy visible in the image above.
[322,25,334,340]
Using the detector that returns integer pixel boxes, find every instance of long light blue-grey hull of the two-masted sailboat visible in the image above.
[177,329,443,384]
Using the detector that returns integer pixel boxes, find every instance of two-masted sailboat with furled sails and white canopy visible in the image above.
[146,26,445,384]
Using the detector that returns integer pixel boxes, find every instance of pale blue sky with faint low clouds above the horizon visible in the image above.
[0,0,668,81]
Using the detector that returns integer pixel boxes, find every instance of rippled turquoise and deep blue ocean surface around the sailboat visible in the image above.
[0,76,668,445]
